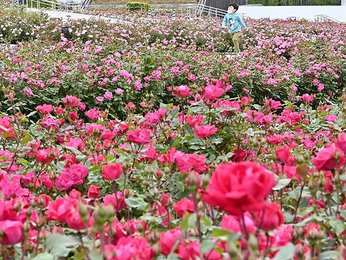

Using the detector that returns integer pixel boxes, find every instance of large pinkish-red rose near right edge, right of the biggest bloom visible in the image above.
[312,145,344,171]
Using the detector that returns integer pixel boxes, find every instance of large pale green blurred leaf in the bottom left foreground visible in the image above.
[46,233,80,257]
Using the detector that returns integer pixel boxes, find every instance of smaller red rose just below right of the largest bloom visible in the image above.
[256,202,285,231]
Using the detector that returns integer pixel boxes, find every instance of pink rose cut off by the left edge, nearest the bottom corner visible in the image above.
[0,220,23,245]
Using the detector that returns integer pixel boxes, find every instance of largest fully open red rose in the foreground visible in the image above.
[203,162,275,215]
